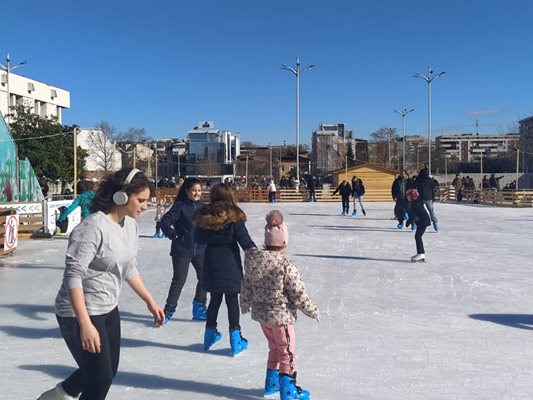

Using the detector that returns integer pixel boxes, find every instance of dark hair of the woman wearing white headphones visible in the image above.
[90,168,154,213]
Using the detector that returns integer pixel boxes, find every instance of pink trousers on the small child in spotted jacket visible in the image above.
[261,323,296,375]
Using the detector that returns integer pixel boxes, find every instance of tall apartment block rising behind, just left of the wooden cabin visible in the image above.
[311,124,368,176]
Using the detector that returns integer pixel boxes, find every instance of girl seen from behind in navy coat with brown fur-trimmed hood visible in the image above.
[193,183,256,356]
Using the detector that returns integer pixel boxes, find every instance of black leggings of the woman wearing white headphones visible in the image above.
[56,308,120,400]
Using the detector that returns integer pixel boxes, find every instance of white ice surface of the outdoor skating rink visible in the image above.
[0,203,533,400]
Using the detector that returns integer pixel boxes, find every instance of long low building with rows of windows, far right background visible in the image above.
[435,133,520,163]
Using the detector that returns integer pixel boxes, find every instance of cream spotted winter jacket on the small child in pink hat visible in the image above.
[240,249,318,325]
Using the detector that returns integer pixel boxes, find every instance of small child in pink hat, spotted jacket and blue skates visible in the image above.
[240,210,318,399]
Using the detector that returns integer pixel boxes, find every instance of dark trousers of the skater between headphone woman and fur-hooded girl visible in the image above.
[165,254,207,311]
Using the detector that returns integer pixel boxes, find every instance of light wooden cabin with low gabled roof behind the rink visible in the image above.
[332,163,399,201]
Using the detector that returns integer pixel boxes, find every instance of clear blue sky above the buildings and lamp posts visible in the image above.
[4,0,533,145]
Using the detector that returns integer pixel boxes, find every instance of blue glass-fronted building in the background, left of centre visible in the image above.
[186,121,240,175]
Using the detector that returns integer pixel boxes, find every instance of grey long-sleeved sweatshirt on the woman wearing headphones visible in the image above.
[55,211,139,317]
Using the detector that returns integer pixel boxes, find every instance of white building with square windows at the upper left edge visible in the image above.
[0,70,70,124]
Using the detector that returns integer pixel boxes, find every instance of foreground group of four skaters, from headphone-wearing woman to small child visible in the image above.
[39,168,319,400]
